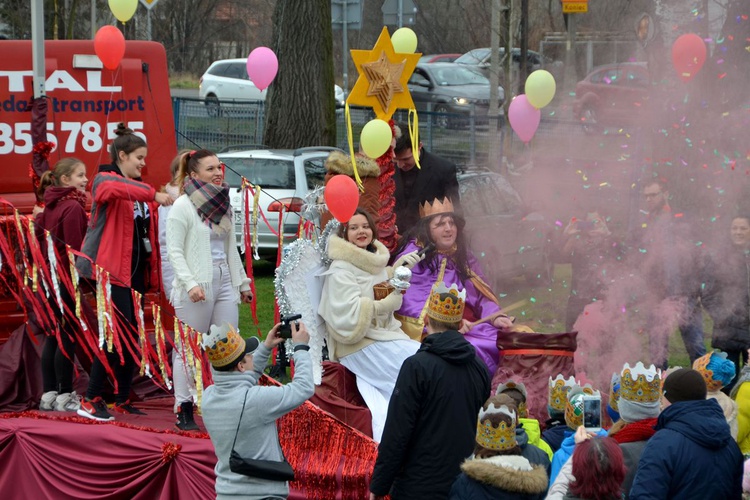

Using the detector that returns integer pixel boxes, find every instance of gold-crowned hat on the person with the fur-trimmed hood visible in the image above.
[476,396,518,452]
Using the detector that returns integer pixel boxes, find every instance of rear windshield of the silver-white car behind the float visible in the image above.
[221,158,295,189]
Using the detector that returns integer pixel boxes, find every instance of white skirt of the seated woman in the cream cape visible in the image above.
[339,340,420,443]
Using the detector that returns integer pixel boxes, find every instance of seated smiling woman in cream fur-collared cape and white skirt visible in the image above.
[318,209,420,442]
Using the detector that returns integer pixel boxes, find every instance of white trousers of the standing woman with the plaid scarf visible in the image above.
[172,261,239,412]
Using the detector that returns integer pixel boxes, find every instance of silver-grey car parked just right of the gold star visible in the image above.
[408,63,505,128]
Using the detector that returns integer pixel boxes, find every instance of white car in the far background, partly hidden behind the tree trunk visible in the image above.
[198,59,344,116]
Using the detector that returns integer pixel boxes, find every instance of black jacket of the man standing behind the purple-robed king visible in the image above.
[393,148,461,234]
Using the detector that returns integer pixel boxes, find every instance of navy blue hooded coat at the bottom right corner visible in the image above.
[630,399,743,500]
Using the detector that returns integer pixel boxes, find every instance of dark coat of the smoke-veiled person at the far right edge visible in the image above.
[701,246,750,351]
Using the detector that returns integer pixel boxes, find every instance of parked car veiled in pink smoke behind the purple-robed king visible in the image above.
[458,169,554,292]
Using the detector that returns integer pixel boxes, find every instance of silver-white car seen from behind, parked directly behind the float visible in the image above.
[218,146,341,258]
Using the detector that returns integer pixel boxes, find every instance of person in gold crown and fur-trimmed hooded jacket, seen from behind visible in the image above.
[449,395,549,500]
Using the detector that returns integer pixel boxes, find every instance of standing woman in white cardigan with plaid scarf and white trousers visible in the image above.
[167,149,252,430]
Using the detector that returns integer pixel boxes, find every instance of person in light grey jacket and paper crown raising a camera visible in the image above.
[202,323,315,500]
